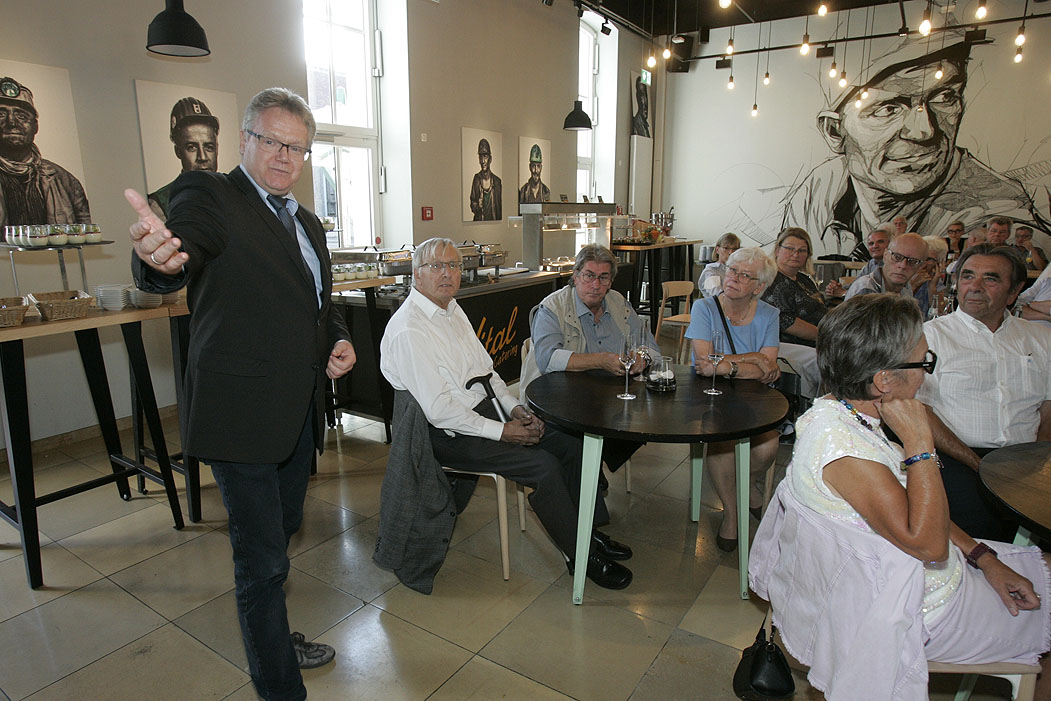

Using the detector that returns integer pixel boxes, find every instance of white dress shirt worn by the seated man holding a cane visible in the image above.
[379,288,518,440]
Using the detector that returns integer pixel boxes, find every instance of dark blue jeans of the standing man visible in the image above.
[211,410,315,701]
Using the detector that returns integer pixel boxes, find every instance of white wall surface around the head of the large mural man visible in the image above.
[663,0,1051,256]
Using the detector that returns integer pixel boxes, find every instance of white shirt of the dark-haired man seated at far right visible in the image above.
[916,309,1051,448]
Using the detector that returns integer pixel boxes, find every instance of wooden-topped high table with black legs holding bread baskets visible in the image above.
[0,307,183,589]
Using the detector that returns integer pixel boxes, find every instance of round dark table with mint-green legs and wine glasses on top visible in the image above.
[526,366,788,603]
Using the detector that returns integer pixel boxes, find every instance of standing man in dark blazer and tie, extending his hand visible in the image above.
[125,87,355,700]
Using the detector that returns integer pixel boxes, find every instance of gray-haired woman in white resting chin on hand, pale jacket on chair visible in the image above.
[748,294,1051,701]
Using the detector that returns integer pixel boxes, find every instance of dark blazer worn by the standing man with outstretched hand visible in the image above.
[131,161,350,462]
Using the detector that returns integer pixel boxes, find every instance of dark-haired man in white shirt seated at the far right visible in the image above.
[916,244,1051,540]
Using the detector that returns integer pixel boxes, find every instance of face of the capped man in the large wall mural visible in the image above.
[823,62,966,195]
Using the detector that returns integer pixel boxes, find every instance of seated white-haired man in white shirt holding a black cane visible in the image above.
[379,239,632,590]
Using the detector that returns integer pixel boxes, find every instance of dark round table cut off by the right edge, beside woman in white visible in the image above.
[978,441,1051,545]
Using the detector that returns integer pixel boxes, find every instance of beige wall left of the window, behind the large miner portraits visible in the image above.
[0,0,313,439]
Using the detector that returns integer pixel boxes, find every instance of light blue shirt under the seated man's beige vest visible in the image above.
[532,293,660,373]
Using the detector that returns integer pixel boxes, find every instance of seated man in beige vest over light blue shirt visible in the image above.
[519,243,660,485]
